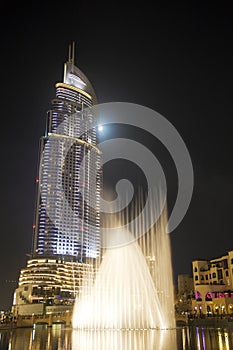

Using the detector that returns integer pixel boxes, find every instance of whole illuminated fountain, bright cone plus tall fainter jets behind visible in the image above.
[72,196,175,331]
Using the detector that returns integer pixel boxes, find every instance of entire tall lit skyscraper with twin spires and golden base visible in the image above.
[13,44,102,315]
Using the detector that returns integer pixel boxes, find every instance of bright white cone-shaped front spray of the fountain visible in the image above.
[73,231,166,329]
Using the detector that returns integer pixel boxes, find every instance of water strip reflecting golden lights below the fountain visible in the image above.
[0,325,233,350]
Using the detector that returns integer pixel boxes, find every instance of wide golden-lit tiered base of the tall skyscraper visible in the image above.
[12,258,94,316]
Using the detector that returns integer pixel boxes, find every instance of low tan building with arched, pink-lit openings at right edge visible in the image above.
[192,251,233,315]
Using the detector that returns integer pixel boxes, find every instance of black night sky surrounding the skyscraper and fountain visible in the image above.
[0,0,233,309]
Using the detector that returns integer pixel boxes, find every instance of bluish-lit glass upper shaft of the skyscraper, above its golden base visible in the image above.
[32,52,102,261]
